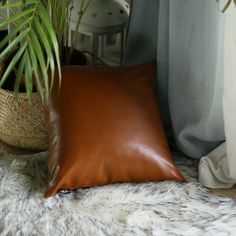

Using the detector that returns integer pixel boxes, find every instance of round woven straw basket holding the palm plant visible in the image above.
[0,89,48,150]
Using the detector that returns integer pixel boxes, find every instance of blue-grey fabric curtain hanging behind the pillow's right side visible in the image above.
[124,0,225,158]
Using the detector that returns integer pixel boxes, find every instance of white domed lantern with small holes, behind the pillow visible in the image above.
[70,0,130,64]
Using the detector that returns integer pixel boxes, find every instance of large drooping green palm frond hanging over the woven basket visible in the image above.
[0,0,61,99]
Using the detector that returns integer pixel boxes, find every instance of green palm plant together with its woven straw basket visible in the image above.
[0,0,91,149]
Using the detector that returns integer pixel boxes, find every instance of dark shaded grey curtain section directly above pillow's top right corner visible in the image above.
[124,0,159,66]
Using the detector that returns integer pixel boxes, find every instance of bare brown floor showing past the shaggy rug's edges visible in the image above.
[0,140,236,199]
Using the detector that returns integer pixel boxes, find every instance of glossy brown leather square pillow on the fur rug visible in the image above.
[45,64,184,197]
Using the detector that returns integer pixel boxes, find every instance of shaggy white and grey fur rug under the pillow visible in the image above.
[0,150,236,236]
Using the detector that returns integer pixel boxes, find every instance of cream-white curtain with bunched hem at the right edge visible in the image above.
[199,5,236,188]
